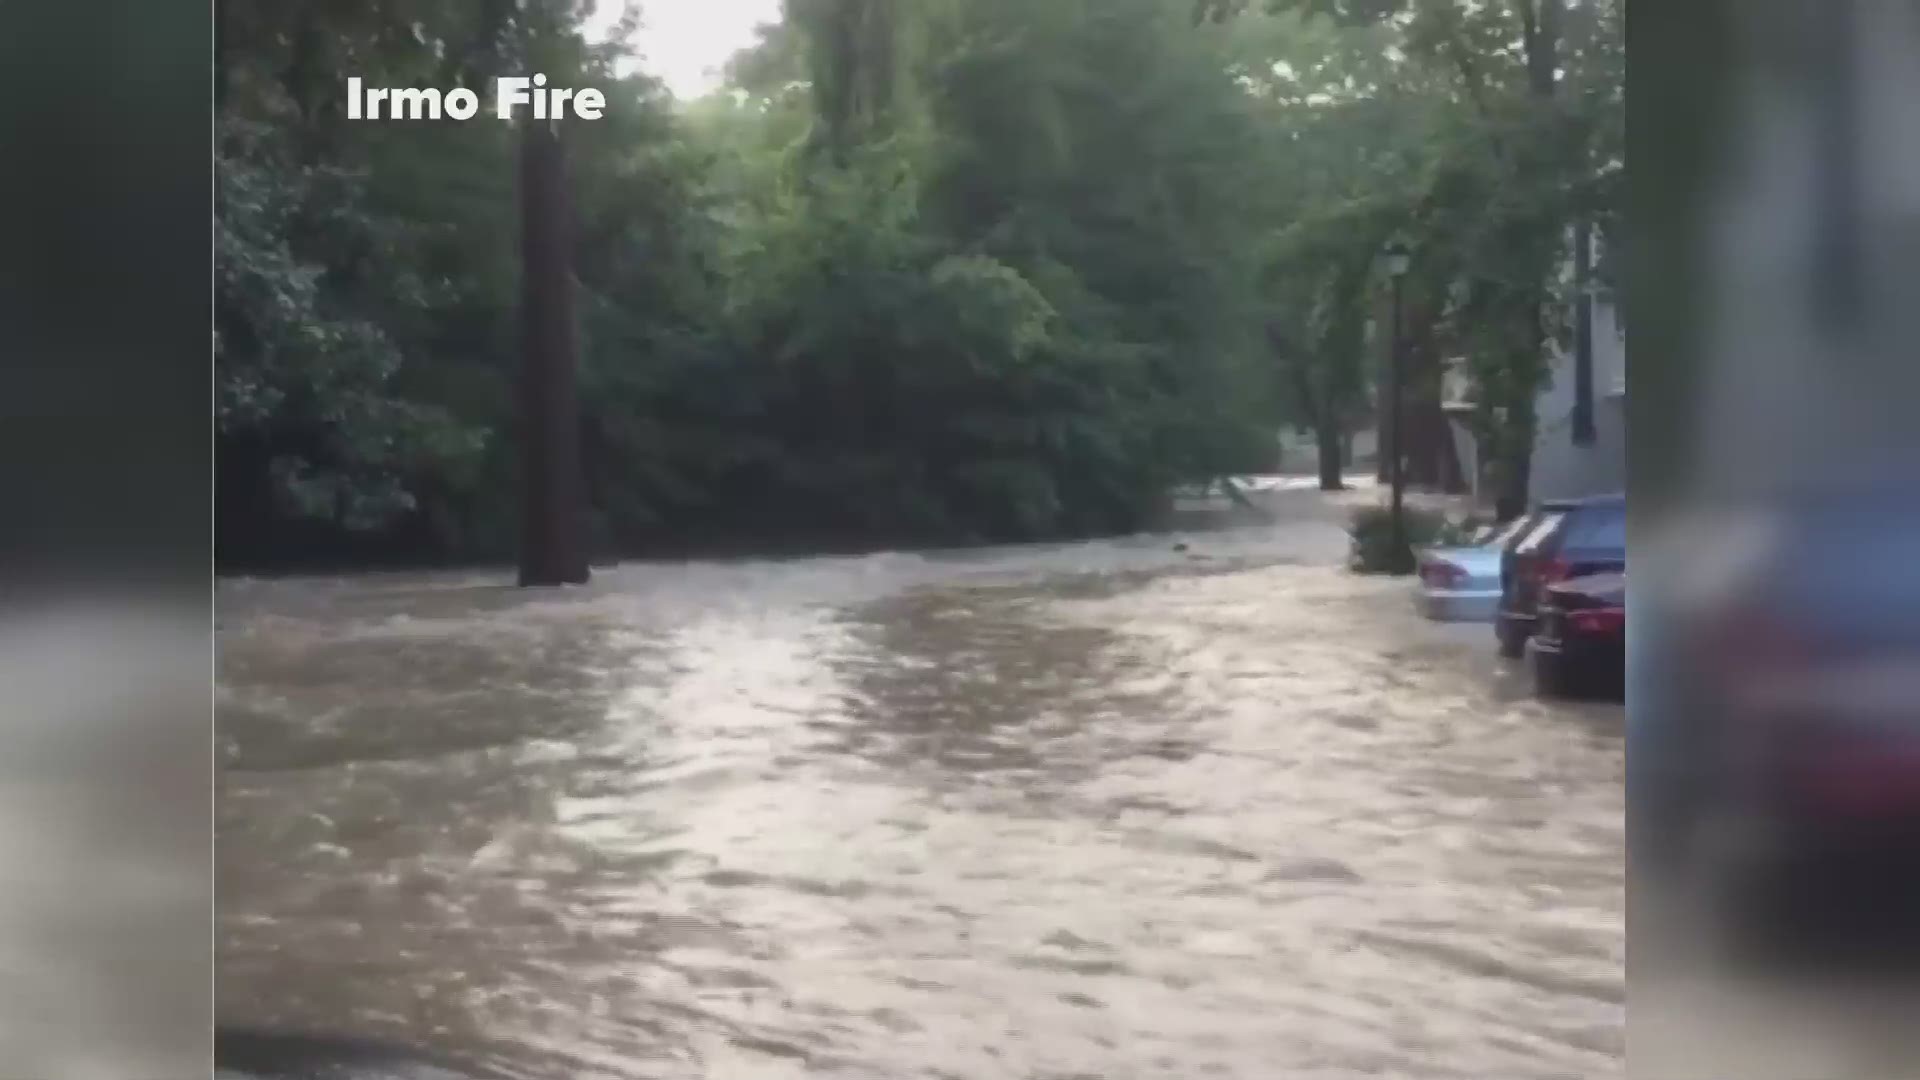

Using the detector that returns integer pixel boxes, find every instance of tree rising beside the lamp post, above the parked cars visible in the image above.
[1194,0,1624,513]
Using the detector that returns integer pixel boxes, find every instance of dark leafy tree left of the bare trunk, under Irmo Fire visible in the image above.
[217,0,680,557]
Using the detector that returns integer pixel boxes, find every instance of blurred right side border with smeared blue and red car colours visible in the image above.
[1626,0,1920,1080]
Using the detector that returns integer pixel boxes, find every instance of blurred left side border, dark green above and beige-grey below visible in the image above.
[0,0,213,1076]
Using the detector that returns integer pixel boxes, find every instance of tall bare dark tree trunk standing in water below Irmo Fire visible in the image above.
[520,119,591,588]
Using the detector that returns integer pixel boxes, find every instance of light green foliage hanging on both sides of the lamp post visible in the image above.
[1192,0,1626,495]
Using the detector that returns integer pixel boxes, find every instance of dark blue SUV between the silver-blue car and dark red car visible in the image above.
[1494,496,1626,659]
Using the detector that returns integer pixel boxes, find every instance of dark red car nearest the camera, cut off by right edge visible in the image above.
[1526,573,1626,698]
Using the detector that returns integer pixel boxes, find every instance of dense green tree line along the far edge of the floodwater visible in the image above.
[215,0,1607,567]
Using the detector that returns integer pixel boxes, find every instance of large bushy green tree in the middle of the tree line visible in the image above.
[927,0,1277,488]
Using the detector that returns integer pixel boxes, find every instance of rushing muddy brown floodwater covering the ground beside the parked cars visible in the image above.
[217,492,1626,1080]
